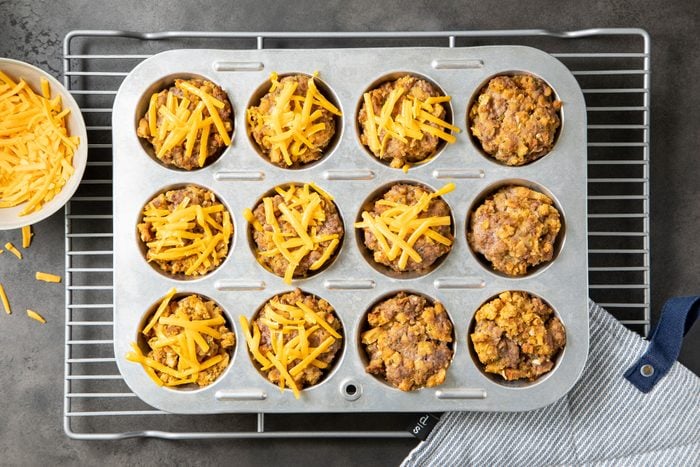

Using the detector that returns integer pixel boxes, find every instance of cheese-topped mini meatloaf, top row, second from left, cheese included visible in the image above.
[247,74,341,168]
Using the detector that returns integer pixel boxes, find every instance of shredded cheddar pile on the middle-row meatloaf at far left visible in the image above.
[142,190,233,276]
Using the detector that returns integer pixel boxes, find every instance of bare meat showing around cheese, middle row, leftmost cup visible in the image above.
[137,185,231,276]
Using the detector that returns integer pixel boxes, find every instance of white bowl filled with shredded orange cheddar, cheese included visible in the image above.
[0,58,87,230]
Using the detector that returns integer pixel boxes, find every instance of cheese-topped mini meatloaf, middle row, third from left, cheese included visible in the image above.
[355,183,454,274]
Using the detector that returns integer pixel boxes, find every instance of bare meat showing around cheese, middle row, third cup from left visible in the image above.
[364,184,453,273]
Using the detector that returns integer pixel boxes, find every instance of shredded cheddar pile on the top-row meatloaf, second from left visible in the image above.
[247,73,342,166]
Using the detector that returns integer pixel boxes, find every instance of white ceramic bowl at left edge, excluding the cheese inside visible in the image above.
[0,58,87,230]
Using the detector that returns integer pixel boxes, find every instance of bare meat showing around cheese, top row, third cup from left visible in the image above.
[358,75,446,168]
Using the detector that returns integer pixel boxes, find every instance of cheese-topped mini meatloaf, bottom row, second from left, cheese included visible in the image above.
[253,289,343,390]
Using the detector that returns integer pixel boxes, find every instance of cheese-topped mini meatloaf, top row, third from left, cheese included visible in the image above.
[358,75,459,168]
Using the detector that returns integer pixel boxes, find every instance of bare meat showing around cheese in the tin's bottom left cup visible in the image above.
[146,295,236,387]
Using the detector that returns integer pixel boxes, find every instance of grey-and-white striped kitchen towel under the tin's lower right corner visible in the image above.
[402,302,700,466]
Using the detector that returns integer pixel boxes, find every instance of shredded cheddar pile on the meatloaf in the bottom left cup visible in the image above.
[126,288,235,386]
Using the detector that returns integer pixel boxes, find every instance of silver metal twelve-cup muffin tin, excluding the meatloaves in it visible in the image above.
[113,46,588,413]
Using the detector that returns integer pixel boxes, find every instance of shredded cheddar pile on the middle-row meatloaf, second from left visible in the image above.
[243,183,342,284]
